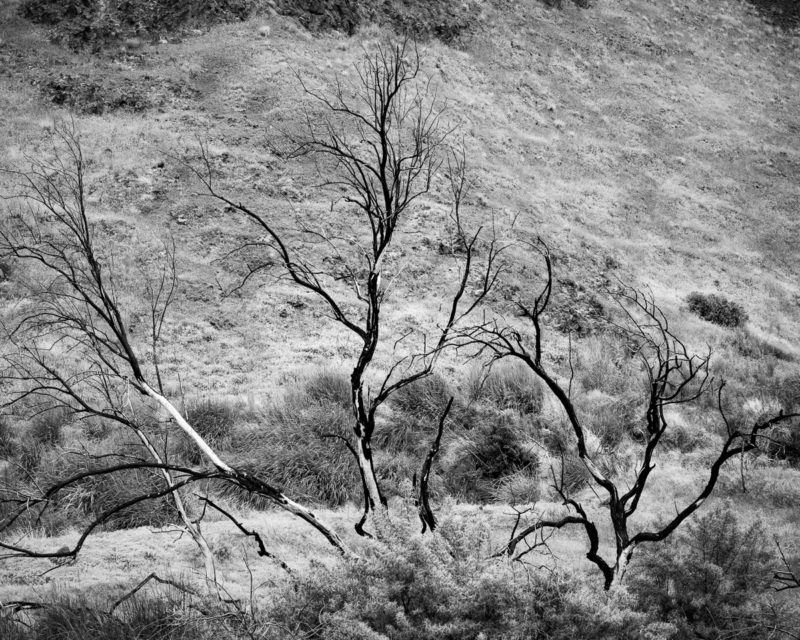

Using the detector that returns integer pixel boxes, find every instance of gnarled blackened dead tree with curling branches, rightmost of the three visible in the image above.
[460,241,799,589]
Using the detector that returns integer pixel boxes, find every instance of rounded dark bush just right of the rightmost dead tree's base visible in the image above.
[630,505,776,639]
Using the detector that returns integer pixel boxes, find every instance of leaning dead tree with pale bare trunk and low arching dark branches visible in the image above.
[0,125,346,564]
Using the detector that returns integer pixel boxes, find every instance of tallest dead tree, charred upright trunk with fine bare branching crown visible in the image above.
[196,41,502,534]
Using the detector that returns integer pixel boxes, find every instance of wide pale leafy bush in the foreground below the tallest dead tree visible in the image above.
[270,514,675,640]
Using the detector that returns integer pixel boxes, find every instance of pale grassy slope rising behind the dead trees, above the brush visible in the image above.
[0,0,800,604]
